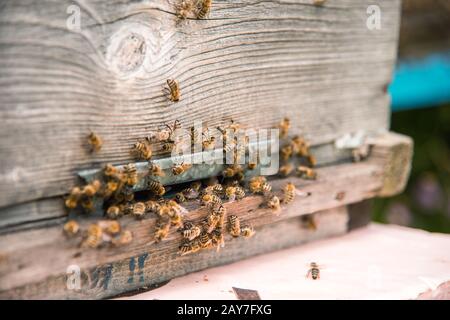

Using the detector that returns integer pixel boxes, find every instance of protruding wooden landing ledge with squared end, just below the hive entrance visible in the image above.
[0,131,412,295]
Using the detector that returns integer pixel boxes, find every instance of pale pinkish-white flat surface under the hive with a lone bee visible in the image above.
[123,224,450,300]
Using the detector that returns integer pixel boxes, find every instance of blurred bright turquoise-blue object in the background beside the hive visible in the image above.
[389,52,450,111]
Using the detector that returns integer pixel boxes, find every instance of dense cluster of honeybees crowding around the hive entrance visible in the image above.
[64,118,317,255]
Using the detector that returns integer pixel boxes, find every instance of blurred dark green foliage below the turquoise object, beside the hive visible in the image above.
[373,104,450,233]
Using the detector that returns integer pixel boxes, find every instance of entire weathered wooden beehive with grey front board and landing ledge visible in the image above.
[0,0,412,298]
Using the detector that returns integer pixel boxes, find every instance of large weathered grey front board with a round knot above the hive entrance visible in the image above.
[0,0,400,207]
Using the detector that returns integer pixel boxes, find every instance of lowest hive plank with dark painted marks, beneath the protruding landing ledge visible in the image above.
[0,207,348,299]
